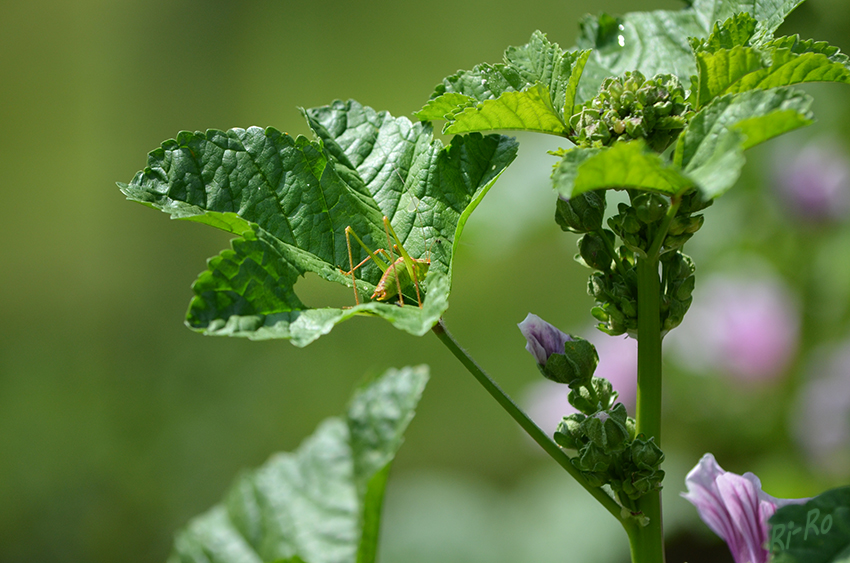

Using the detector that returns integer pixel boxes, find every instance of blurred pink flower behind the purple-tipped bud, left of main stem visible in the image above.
[522,330,637,432]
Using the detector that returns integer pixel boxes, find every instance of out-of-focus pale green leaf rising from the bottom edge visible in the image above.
[169,366,428,563]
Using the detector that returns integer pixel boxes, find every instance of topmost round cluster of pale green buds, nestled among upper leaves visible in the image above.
[570,71,693,152]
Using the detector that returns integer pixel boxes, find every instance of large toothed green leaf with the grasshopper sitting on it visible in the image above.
[119,101,517,346]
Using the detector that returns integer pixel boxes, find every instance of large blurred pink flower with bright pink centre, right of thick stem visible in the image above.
[669,275,799,380]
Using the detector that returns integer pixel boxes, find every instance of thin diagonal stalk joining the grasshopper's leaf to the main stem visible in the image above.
[431,319,636,536]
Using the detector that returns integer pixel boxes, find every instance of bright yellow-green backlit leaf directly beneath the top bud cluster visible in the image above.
[552,140,693,199]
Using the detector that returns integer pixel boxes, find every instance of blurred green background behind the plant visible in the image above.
[0,0,850,563]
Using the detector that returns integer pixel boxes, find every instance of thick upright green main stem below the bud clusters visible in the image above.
[629,256,664,563]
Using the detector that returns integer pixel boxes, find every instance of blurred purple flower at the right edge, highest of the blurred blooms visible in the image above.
[774,142,850,223]
